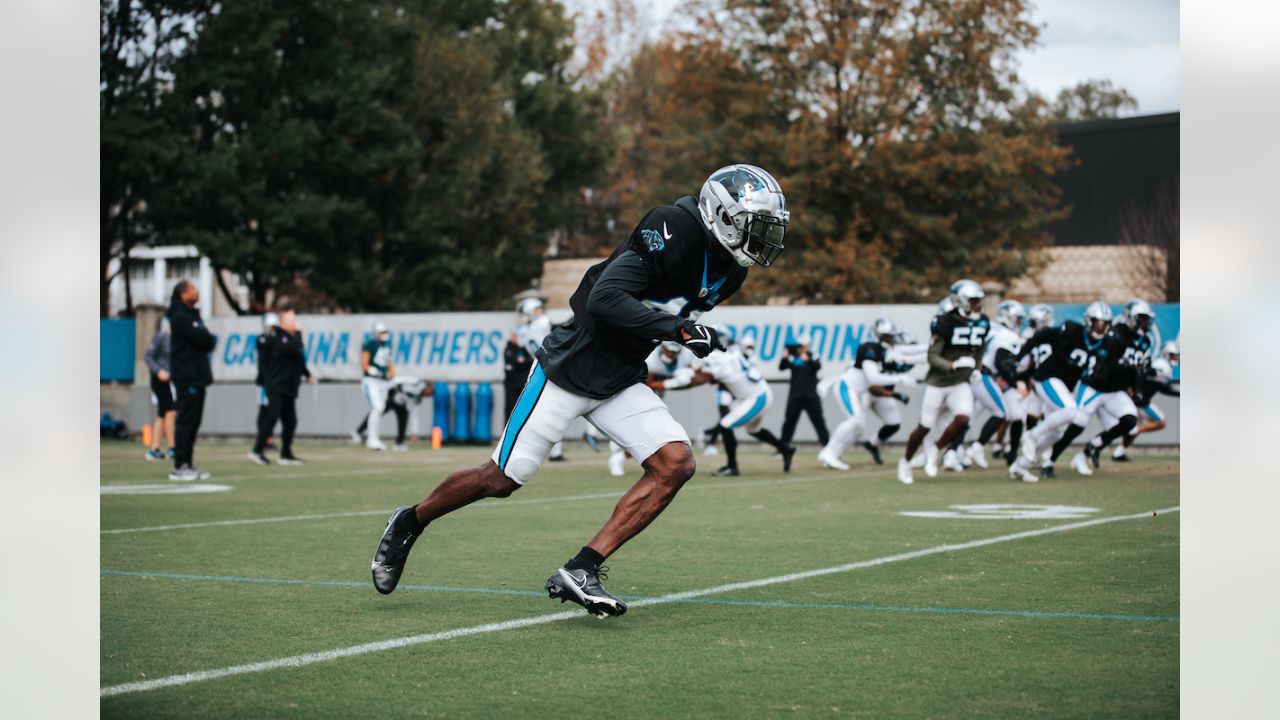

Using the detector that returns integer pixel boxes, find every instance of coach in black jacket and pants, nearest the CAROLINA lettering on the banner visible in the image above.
[248,310,315,465]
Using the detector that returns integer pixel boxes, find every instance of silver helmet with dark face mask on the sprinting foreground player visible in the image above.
[698,165,791,268]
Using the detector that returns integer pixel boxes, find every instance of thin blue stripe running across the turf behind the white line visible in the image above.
[99,570,1179,623]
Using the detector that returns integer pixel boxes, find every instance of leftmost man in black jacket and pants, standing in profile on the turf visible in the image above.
[169,281,218,480]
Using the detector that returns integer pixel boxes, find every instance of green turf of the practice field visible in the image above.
[101,435,1179,719]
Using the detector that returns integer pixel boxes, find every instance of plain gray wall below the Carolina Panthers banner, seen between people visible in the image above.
[128,383,1179,445]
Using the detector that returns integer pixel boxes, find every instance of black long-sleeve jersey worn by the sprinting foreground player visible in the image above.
[538,196,746,398]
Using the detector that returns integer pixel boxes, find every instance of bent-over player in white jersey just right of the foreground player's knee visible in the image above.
[667,346,796,475]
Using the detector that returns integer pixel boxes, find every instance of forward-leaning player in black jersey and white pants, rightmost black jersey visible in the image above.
[1052,300,1155,475]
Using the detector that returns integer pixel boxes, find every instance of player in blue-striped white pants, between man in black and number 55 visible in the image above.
[818,318,916,470]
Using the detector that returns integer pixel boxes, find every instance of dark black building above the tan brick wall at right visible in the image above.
[1050,113,1180,245]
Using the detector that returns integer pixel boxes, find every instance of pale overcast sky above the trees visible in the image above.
[599,0,1179,115]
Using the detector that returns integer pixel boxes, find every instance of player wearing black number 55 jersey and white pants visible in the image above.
[897,279,991,484]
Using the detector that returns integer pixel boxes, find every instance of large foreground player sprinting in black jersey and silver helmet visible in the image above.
[372,165,790,618]
